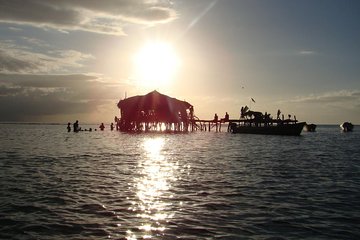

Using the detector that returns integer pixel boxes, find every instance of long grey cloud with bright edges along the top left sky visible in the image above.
[0,0,177,35]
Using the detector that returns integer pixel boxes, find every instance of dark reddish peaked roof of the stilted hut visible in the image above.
[117,90,192,113]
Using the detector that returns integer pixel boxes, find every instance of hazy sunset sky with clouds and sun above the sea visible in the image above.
[0,0,360,124]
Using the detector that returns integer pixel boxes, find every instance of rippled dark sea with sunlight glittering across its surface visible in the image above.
[0,124,360,240]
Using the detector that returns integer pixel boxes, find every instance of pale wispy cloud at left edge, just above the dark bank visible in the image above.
[0,39,93,73]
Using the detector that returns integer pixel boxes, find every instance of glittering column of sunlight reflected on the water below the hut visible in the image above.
[127,137,178,239]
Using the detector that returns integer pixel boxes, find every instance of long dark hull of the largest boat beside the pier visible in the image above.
[230,122,305,136]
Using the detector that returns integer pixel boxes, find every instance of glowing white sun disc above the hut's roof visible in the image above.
[134,42,179,88]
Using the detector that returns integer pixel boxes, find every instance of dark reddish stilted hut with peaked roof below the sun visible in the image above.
[116,91,194,132]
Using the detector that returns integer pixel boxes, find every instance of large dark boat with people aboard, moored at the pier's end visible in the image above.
[228,106,306,136]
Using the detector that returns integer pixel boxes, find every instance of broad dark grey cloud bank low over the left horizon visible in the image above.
[0,74,123,121]
